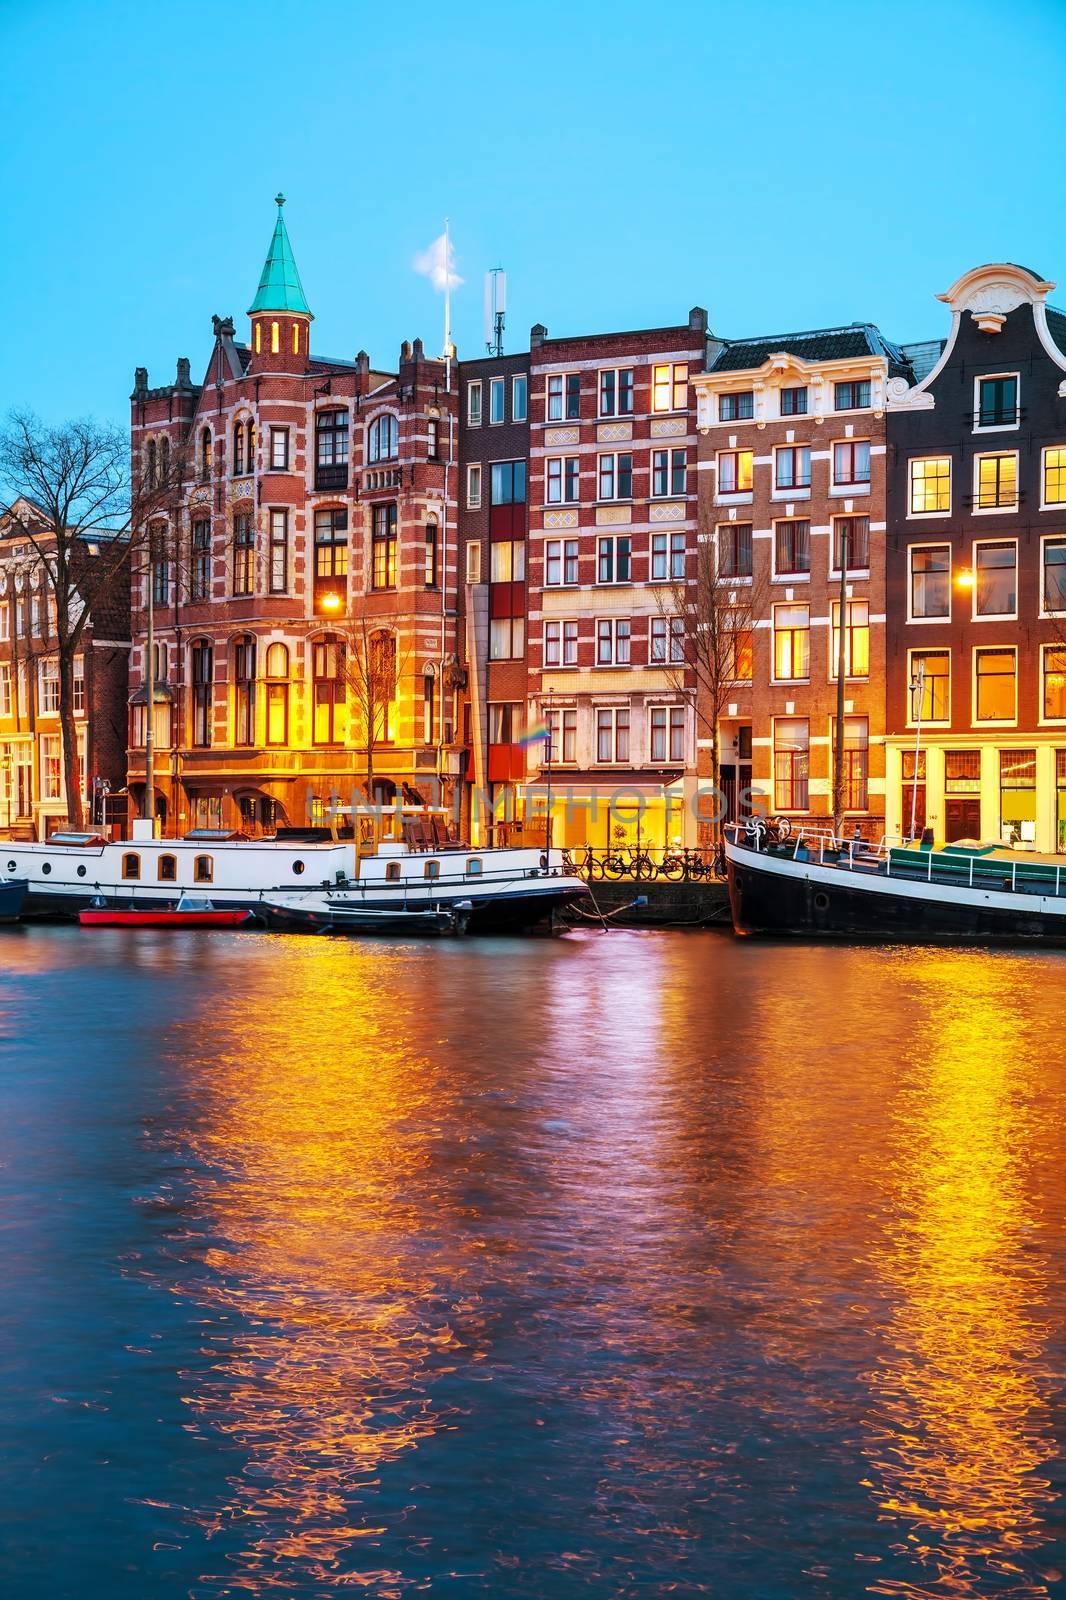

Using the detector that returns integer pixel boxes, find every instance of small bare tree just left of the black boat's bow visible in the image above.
[658,538,767,846]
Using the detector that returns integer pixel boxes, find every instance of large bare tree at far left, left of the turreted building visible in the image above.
[0,411,181,827]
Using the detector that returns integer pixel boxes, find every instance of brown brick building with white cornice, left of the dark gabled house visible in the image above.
[695,323,909,834]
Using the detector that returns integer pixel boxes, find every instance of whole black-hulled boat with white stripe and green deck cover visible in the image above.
[725,818,1066,944]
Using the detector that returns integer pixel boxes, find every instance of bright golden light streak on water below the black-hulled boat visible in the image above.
[868,952,1061,1600]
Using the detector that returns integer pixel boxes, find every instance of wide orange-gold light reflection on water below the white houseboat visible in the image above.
[160,941,479,1600]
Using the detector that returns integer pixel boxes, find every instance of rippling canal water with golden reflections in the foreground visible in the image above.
[0,928,1066,1600]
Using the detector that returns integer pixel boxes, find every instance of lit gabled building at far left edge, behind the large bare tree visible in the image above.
[0,499,130,838]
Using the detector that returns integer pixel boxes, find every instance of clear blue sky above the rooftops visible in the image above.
[0,0,1066,424]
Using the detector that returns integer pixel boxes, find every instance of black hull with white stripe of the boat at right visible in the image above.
[727,845,1066,946]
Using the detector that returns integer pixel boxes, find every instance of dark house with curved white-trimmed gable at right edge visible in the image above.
[887,264,1066,851]
